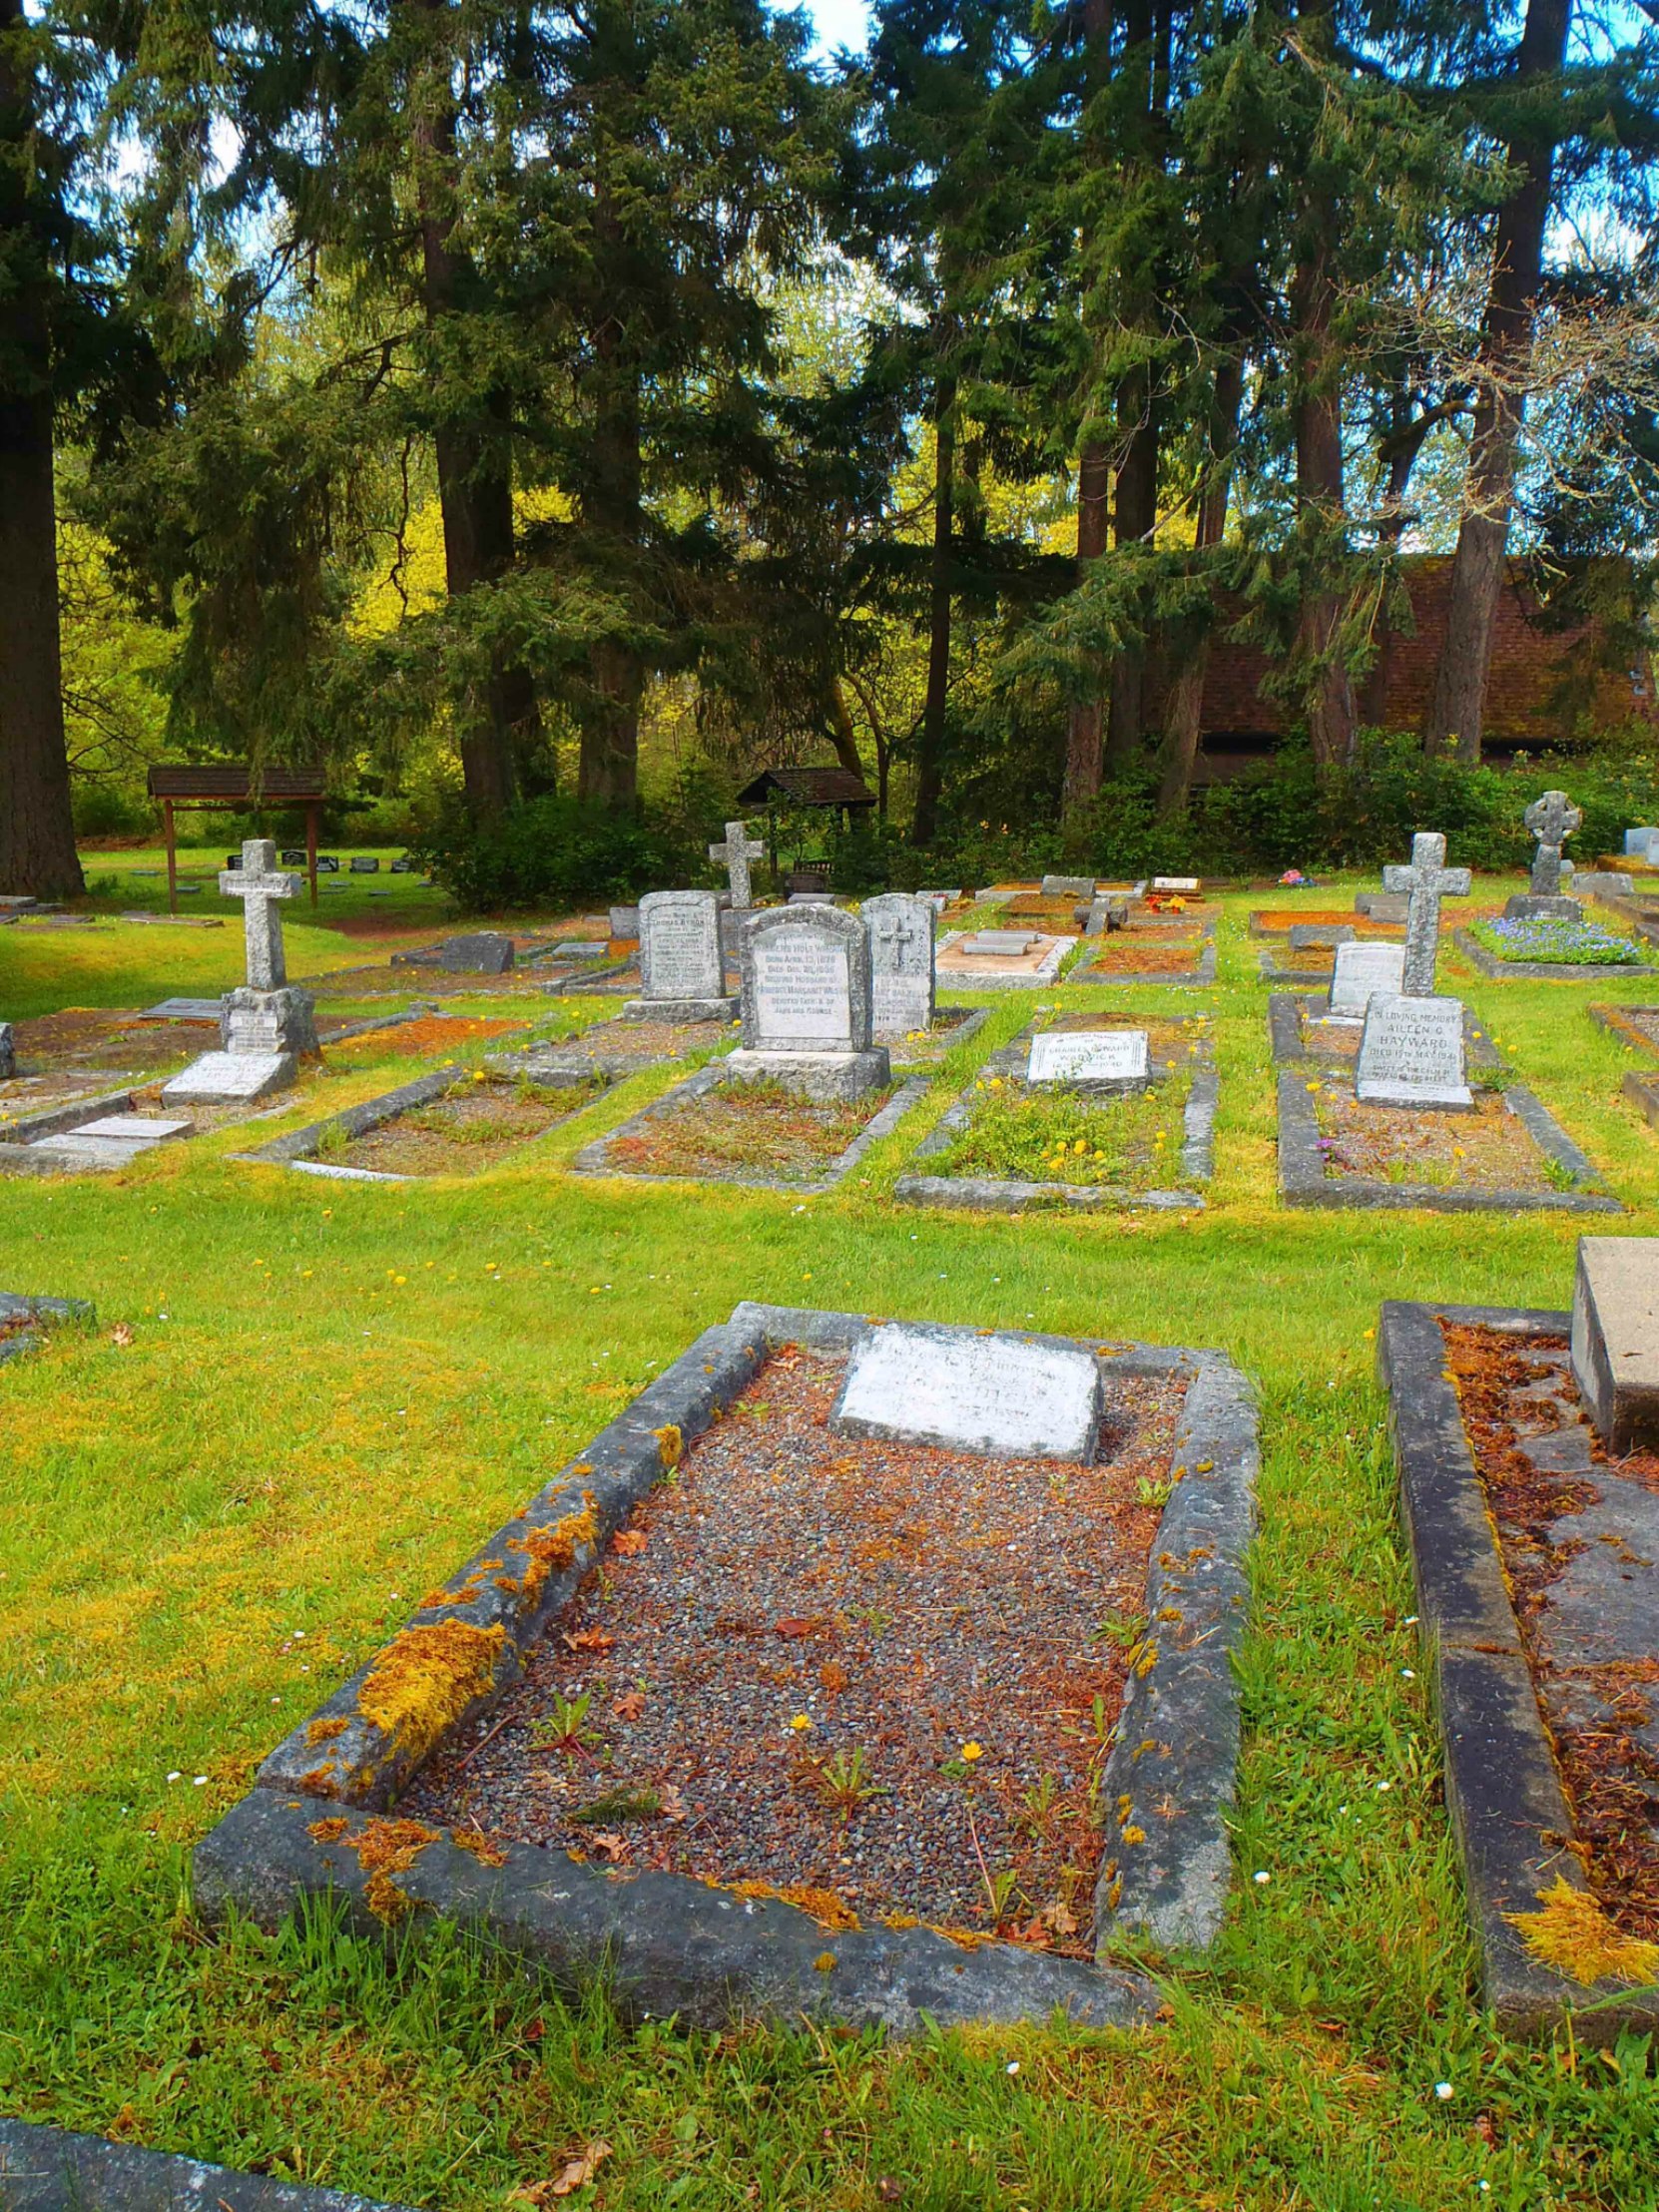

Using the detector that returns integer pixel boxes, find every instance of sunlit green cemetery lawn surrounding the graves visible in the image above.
[0,871,1659,2212]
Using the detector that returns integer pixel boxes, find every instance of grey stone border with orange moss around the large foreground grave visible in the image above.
[195,1301,1259,2033]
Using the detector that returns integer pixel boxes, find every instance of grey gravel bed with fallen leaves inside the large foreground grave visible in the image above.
[398,1348,1184,1955]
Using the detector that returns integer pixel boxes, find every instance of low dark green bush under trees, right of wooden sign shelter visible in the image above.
[411,792,695,913]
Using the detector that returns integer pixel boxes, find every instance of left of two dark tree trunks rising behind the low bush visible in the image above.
[411,0,540,821]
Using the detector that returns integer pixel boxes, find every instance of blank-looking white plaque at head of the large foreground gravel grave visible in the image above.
[830,1323,1099,1460]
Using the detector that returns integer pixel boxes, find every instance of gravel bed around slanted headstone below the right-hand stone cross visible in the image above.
[1308,1070,1557,1190]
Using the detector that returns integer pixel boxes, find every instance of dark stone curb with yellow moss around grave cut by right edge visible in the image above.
[1376,1299,1659,2044]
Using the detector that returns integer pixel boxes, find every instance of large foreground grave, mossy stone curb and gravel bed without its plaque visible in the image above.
[195,1305,1257,2033]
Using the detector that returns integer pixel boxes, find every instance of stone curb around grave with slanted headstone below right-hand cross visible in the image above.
[1268,991,1624,1215]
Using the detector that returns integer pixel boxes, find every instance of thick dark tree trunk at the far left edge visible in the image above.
[0,0,86,898]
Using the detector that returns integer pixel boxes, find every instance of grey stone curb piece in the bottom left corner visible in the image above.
[0,2119,407,2212]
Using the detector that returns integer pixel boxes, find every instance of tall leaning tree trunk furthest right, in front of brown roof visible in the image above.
[1422,0,1573,761]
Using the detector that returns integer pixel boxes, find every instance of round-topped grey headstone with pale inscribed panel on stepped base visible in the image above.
[726,907,891,1099]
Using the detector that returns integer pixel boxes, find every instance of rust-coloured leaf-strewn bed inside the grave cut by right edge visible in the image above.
[1440,1321,1659,1942]
